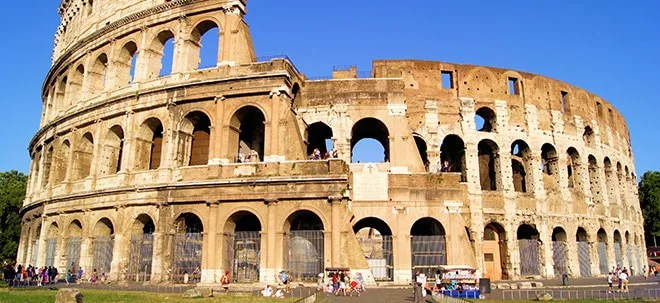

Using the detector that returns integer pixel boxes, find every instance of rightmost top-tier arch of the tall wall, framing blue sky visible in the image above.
[190,20,220,69]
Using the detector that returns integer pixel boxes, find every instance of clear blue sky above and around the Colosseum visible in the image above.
[0,0,660,175]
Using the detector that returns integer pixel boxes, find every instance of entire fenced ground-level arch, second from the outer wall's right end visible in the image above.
[224,211,262,283]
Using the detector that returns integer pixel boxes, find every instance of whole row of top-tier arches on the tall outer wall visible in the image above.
[44,19,220,119]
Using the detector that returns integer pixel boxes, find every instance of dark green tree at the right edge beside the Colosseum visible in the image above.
[639,171,660,246]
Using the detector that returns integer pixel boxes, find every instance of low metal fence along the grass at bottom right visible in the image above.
[502,288,660,300]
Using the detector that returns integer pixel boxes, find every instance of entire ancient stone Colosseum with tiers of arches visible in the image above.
[17,0,647,284]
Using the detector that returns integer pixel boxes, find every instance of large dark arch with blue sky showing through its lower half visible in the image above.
[351,117,390,162]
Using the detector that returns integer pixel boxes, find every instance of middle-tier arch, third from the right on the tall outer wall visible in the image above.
[135,118,163,170]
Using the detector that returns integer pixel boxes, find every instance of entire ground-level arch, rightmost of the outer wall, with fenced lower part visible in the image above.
[284,210,324,282]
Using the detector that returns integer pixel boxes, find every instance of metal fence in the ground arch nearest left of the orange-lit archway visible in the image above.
[410,236,447,277]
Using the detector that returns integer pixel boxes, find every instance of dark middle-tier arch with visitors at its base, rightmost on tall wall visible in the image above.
[228,106,266,163]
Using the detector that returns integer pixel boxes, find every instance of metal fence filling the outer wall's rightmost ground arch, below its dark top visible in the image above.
[285,230,324,281]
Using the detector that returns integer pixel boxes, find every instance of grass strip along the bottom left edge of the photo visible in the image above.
[0,289,296,303]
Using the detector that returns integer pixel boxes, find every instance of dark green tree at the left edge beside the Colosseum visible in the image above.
[0,170,27,260]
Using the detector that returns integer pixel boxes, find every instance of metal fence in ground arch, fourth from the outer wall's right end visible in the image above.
[127,234,154,281]
